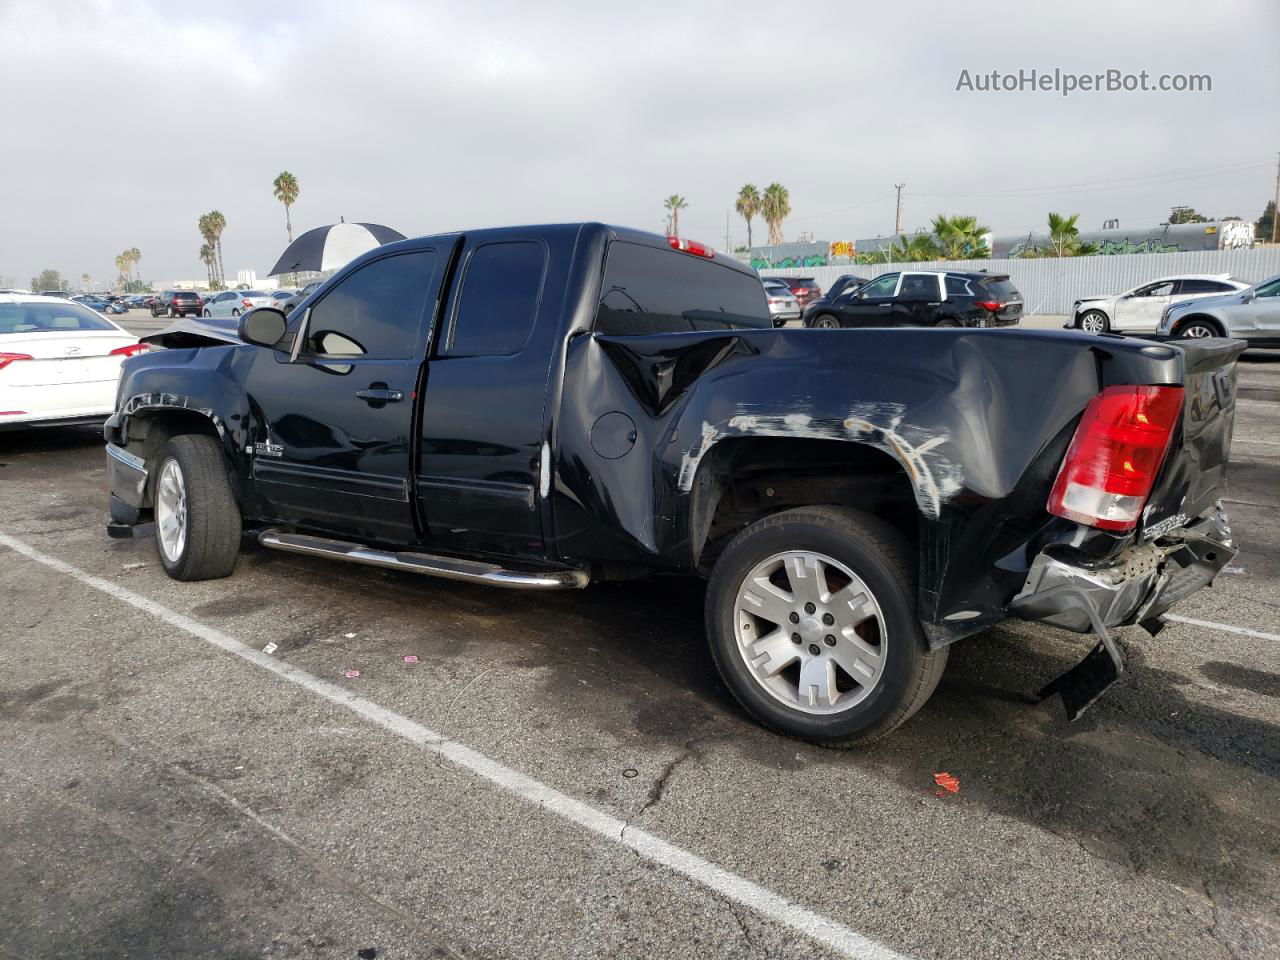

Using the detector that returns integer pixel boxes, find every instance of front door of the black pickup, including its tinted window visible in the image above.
[243,239,451,544]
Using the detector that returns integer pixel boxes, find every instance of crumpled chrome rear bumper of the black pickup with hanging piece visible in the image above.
[1009,503,1235,719]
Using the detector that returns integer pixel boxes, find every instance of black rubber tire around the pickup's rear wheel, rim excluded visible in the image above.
[705,507,948,748]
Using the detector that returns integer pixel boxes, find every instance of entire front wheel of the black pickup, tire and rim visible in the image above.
[154,434,241,580]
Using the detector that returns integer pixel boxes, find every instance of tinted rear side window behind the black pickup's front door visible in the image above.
[444,241,547,357]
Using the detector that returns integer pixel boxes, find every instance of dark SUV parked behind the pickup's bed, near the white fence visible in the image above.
[804,270,1023,329]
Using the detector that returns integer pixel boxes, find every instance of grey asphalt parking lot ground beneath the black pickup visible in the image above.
[0,311,1280,960]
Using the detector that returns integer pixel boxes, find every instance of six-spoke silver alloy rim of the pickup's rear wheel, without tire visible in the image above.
[733,550,888,716]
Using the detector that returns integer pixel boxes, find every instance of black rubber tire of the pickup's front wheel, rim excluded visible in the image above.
[151,434,241,580]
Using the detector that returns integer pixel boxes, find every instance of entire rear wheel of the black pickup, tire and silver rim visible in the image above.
[707,507,947,746]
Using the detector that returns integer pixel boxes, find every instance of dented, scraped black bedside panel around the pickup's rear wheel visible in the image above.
[554,329,1208,644]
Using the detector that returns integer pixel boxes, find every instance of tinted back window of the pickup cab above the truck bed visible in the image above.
[595,241,773,337]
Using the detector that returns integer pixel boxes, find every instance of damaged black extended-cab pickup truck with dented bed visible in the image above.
[105,223,1243,745]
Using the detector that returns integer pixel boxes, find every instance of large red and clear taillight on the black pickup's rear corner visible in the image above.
[1048,387,1183,530]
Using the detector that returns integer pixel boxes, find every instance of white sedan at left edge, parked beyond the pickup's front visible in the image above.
[0,294,147,430]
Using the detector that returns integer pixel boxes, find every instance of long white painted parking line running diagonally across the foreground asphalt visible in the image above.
[0,532,908,960]
